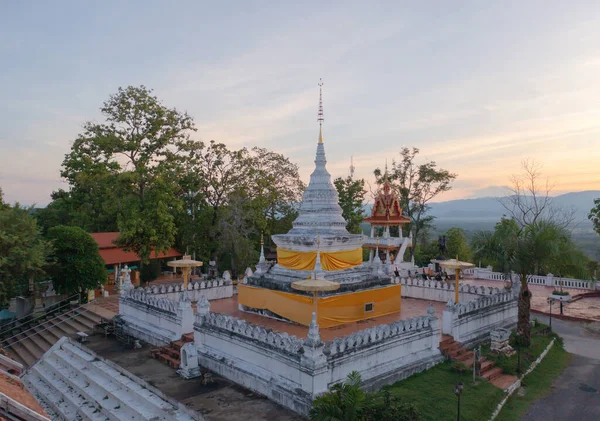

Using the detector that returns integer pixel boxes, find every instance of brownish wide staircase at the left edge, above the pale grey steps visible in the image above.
[0,307,100,367]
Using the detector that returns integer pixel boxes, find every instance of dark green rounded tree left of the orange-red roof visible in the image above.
[47,225,107,300]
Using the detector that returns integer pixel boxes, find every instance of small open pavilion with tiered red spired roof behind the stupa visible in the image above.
[363,168,414,275]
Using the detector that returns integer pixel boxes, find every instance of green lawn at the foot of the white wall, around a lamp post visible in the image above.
[386,363,504,421]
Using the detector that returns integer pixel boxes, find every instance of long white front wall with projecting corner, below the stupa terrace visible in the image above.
[190,296,442,415]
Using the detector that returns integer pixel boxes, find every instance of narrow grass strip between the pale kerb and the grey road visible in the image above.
[496,340,571,421]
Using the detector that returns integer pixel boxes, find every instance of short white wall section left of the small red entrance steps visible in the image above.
[118,289,194,346]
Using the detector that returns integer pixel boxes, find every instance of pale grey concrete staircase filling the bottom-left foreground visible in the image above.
[23,338,202,421]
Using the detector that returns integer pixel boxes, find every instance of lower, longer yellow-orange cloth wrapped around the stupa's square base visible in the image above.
[238,284,401,328]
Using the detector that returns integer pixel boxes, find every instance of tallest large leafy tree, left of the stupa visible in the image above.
[61,86,195,262]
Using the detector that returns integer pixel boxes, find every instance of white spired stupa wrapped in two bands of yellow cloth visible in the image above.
[238,83,400,327]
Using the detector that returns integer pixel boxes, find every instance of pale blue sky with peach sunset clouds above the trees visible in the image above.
[0,0,600,206]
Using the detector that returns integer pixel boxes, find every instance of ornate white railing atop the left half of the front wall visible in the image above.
[195,312,303,357]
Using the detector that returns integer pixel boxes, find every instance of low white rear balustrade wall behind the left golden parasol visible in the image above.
[138,279,233,303]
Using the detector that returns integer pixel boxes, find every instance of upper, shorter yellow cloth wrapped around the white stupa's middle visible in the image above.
[277,247,362,270]
